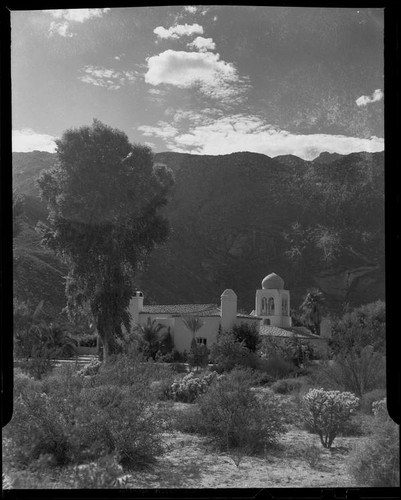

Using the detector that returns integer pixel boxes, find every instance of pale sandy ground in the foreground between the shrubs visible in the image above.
[124,429,363,488]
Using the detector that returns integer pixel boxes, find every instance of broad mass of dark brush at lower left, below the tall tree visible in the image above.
[7,363,162,468]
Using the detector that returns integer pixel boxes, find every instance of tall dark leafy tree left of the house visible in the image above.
[38,120,173,359]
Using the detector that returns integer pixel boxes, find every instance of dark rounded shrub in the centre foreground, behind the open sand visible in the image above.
[194,369,284,454]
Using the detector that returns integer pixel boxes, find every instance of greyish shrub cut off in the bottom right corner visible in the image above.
[347,403,400,487]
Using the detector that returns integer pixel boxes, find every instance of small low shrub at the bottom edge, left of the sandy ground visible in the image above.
[74,455,129,489]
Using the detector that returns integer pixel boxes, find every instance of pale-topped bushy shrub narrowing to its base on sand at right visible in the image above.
[303,389,359,448]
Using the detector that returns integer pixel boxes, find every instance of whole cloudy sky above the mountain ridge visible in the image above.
[11,5,384,160]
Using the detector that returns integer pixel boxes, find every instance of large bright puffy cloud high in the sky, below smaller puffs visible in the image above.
[145,49,248,102]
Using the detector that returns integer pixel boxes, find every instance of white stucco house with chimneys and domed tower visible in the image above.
[129,273,321,352]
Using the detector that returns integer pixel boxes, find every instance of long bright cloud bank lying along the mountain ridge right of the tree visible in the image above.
[139,114,384,160]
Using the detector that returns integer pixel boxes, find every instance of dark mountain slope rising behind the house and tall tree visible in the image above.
[13,152,384,318]
